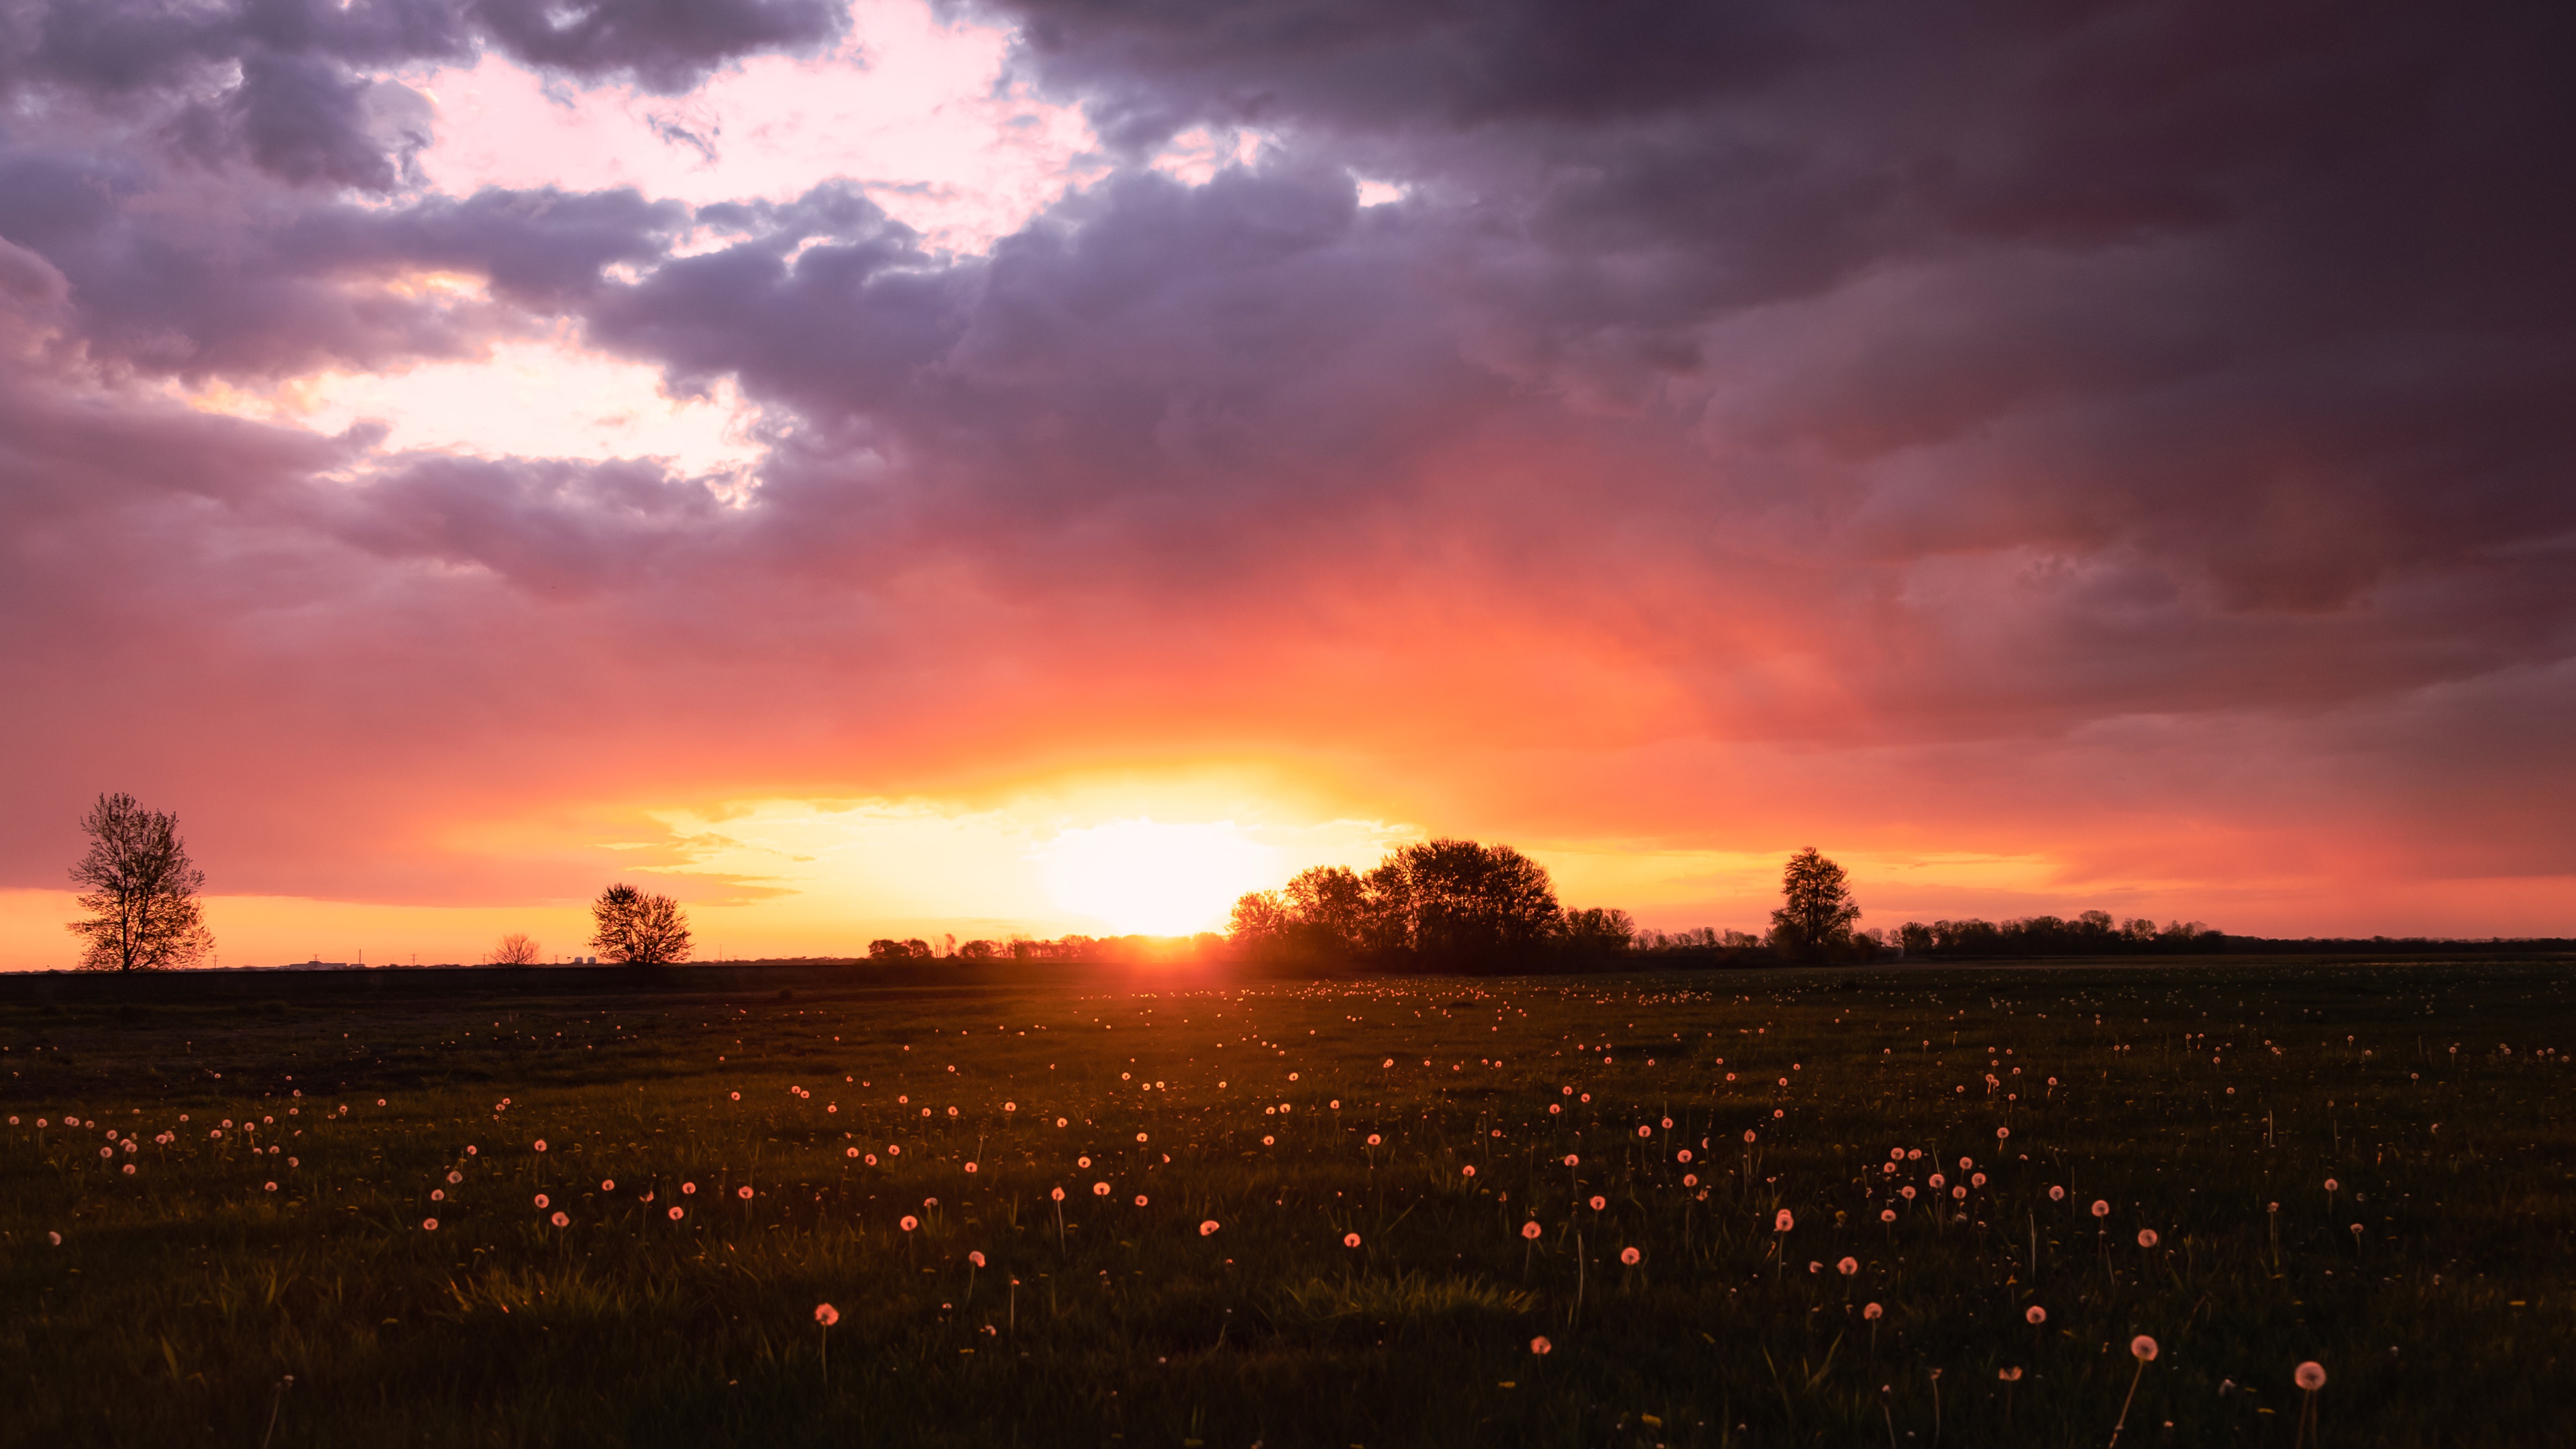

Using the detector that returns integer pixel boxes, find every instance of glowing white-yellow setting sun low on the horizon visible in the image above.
[1038,820,1278,936]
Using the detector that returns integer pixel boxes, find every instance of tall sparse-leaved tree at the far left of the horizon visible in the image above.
[70,794,214,972]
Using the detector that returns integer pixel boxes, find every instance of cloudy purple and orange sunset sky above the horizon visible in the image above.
[0,0,2576,969]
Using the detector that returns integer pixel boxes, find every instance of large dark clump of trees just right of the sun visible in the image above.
[1226,841,1635,972]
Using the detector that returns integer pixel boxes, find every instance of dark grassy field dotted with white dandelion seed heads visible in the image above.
[0,962,2576,1449]
